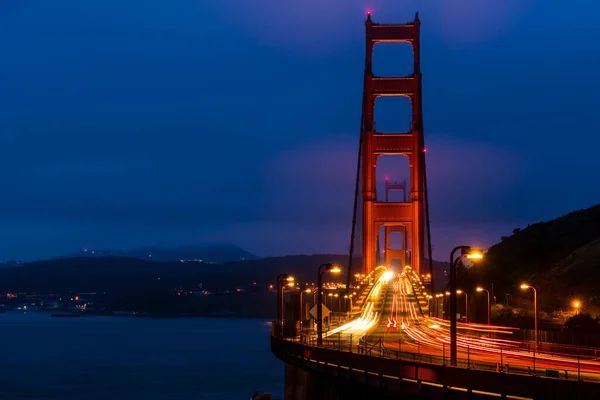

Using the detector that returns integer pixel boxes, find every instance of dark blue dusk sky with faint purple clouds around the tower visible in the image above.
[0,0,600,259]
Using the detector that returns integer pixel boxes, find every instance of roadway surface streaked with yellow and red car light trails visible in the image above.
[326,269,600,380]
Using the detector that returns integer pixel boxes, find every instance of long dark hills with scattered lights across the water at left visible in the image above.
[0,254,444,293]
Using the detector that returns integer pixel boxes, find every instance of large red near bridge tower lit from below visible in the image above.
[361,13,425,274]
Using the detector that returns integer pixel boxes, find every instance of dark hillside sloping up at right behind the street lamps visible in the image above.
[480,205,600,307]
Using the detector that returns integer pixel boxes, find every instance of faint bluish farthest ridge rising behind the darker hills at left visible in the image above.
[67,243,257,263]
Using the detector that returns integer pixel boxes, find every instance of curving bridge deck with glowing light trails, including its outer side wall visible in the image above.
[272,274,600,399]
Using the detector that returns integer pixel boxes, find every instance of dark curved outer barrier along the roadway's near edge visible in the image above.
[271,336,600,399]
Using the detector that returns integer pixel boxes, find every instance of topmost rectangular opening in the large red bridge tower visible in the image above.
[373,42,415,77]
